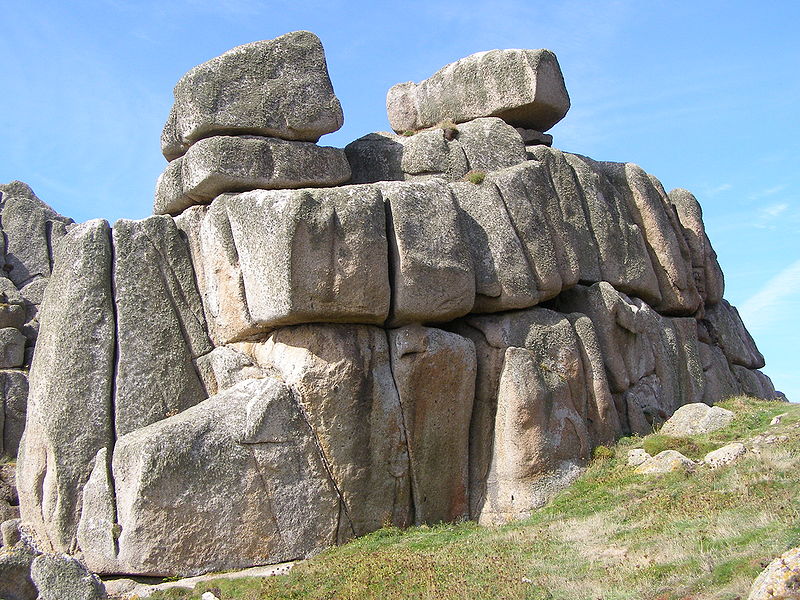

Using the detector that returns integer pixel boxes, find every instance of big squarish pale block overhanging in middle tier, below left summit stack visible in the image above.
[200,186,390,344]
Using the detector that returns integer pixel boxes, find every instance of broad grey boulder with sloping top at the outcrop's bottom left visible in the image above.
[81,378,346,576]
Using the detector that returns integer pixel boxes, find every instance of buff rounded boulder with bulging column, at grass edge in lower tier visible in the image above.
[457,308,620,523]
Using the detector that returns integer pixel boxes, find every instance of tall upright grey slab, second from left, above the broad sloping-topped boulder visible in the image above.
[113,216,212,436]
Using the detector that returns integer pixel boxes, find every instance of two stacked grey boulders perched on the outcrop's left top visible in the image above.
[155,31,350,215]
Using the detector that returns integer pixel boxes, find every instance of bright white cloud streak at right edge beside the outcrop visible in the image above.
[739,260,800,334]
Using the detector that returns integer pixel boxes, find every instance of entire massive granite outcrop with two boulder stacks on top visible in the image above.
[10,32,774,576]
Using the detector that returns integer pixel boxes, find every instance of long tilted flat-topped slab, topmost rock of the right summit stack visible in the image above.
[386,50,569,132]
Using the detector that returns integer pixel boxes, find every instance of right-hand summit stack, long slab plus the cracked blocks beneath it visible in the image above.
[345,50,569,183]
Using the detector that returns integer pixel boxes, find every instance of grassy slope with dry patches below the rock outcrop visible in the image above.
[152,398,800,600]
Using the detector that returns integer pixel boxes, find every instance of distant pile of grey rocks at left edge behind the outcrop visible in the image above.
[0,181,72,468]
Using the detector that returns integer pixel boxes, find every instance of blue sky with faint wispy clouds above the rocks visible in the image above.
[0,0,800,400]
